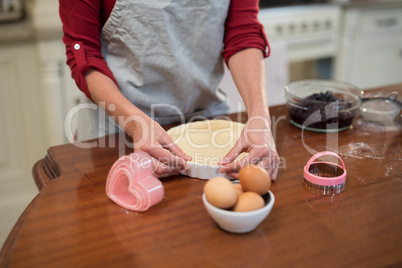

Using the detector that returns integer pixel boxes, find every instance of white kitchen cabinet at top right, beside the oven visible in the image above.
[335,4,402,88]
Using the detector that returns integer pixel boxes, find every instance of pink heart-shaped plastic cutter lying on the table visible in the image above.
[106,152,165,211]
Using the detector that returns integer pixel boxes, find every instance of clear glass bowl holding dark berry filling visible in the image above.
[285,80,363,132]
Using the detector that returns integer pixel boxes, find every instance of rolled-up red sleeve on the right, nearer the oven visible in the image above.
[223,0,270,64]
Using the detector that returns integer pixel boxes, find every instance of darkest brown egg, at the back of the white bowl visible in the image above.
[239,165,271,195]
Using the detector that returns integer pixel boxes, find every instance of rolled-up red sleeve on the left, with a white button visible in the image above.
[59,0,117,99]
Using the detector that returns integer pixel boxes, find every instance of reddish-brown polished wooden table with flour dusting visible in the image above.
[0,85,402,267]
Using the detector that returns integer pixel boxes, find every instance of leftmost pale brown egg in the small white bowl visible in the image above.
[204,177,237,209]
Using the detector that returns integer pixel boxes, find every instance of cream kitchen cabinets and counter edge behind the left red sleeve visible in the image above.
[0,0,87,245]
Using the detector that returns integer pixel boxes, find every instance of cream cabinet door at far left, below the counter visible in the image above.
[0,42,47,244]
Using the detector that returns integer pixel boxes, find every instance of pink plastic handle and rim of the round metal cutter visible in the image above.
[303,151,347,186]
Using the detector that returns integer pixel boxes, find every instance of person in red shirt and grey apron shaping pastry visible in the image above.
[59,0,279,179]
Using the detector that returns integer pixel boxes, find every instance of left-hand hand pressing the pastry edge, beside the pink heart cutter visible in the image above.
[125,117,191,178]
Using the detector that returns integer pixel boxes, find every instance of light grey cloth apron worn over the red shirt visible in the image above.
[95,0,230,136]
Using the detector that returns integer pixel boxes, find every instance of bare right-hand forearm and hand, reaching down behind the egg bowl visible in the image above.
[220,48,279,180]
